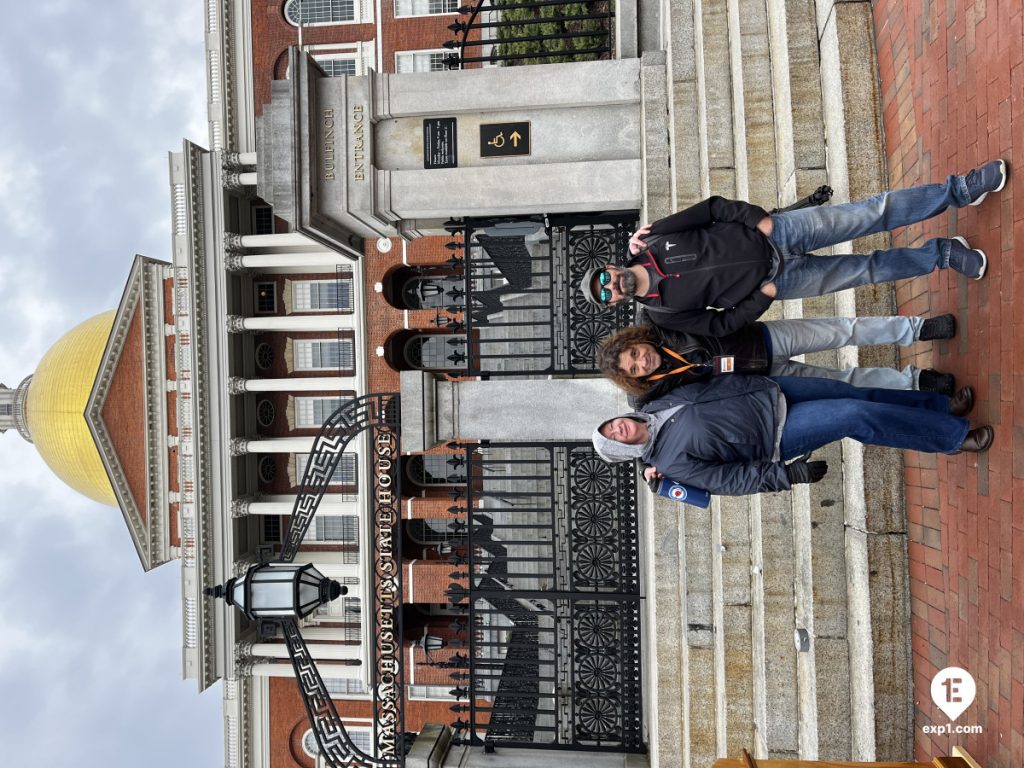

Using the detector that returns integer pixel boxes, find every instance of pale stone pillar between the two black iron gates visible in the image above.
[401,371,633,452]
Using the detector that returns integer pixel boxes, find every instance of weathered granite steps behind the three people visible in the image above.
[639,0,912,768]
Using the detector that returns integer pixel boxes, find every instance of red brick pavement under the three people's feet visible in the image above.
[874,0,1024,768]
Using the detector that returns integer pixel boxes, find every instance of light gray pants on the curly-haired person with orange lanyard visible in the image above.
[764,315,925,389]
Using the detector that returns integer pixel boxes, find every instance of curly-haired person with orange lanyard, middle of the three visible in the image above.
[597,314,963,403]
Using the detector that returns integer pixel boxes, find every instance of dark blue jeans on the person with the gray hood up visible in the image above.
[771,376,970,461]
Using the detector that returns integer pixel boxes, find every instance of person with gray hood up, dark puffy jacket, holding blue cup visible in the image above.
[593,376,994,496]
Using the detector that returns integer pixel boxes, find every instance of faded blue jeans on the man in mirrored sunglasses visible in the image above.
[771,176,971,299]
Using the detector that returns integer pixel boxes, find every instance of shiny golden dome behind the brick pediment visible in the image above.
[25,309,118,507]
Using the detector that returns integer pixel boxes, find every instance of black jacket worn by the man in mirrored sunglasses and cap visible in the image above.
[628,197,781,336]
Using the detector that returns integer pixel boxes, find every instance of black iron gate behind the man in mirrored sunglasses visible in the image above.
[437,211,637,376]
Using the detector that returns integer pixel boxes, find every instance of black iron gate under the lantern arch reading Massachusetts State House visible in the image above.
[446,443,644,752]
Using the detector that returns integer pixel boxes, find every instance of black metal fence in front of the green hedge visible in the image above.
[444,0,614,69]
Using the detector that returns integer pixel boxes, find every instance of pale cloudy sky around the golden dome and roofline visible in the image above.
[0,0,223,768]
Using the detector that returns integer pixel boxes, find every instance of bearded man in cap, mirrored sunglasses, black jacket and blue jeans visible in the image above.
[581,160,1008,336]
